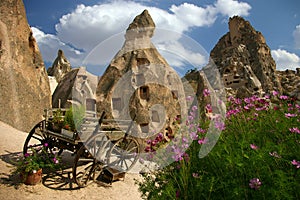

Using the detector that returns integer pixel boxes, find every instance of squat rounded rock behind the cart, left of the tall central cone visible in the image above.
[52,67,98,110]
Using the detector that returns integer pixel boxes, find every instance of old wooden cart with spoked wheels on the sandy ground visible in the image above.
[23,109,140,187]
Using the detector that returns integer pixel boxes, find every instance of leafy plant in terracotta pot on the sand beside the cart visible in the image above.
[13,143,61,185]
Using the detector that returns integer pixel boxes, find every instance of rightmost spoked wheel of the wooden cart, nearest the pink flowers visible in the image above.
[107,138,140,172]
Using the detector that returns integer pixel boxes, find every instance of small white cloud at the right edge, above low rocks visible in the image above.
[271,49,300,70]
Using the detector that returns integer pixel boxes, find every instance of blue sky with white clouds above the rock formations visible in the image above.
[23,0,300,75]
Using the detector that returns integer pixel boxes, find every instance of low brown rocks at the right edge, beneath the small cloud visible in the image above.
[277,68,300,100]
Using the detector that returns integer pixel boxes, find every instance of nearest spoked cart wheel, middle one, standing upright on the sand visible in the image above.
[73,134,110,187]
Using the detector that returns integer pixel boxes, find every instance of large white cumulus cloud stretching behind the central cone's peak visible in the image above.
[34,0,251,73]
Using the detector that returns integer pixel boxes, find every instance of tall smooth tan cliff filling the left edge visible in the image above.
[0,0,51,131]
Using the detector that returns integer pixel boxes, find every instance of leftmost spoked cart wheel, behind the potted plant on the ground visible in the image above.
[23,120,63,155]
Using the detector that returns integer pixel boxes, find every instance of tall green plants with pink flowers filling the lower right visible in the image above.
[137,92,300,199]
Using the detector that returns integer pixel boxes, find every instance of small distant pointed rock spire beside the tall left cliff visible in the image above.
[47,49,71,83]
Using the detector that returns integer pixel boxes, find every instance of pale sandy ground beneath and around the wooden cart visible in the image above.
[0,122,141,200]
